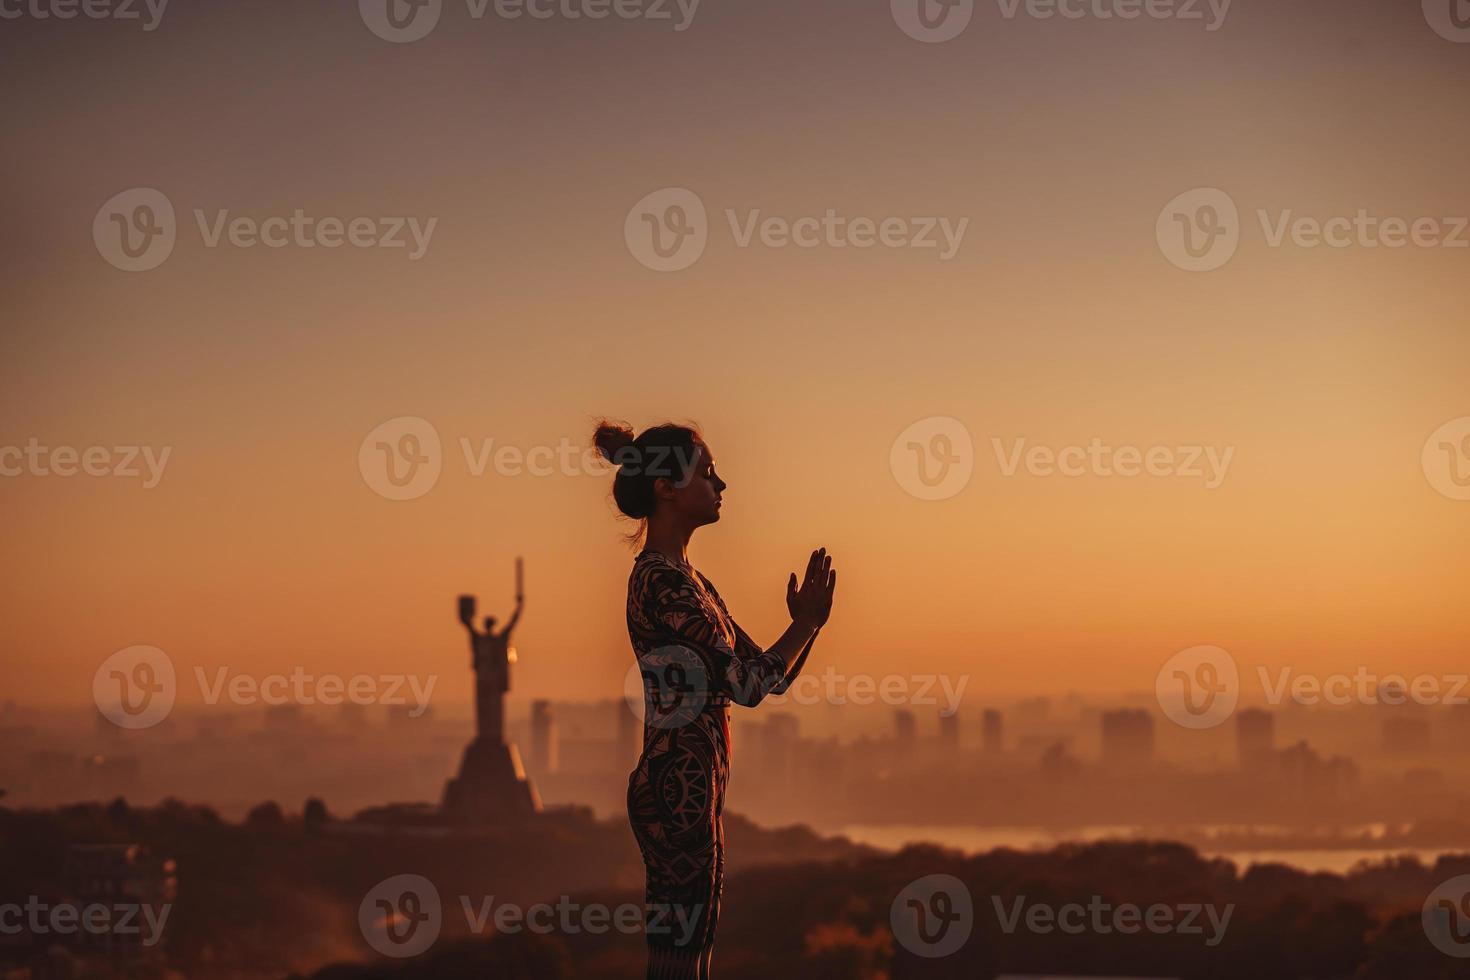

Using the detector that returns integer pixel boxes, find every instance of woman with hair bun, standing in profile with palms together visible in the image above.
[594,422,836,980]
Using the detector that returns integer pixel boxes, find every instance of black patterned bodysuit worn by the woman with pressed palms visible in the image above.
[628,550,800,980]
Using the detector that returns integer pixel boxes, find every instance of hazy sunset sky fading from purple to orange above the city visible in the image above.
[0,0,1470,710]
